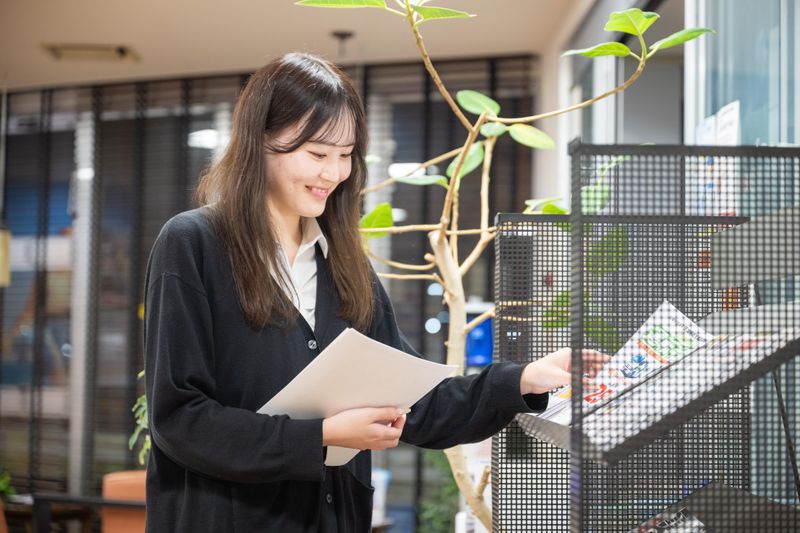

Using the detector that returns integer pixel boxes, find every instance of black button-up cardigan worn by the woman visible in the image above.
[144,208,547,533]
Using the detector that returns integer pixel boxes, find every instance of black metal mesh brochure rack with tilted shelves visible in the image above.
[492,145,800,532]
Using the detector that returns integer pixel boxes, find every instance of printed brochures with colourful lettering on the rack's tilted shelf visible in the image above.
[517,302,800,463]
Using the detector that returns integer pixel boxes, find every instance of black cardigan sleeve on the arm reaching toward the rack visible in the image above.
[371,270,548,448]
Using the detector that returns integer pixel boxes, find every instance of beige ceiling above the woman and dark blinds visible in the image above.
[0,0,586,90]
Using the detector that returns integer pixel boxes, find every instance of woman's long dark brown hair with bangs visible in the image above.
[197,53,374,331]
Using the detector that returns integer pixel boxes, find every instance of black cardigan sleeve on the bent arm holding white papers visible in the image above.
[145,214,324,483]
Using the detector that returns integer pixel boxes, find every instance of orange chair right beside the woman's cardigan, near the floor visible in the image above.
[101,470,147,533]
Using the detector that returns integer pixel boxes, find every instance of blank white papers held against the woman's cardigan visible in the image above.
[258,328,456,466]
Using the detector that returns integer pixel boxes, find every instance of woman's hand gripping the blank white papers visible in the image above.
[322,407,407,450]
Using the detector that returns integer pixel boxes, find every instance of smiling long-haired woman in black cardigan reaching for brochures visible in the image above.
[145,54,608,533]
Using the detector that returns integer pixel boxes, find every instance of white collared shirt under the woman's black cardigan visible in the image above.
[278,217,328,331]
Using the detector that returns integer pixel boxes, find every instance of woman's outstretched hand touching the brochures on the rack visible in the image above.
[519,348,611,394]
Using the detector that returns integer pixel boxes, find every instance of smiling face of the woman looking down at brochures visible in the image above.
[264,120,355,228]
